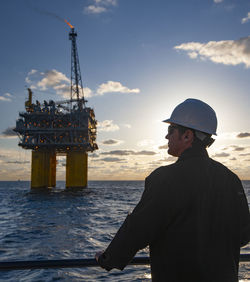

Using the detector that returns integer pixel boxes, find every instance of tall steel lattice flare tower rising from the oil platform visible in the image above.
[69,27,85,107]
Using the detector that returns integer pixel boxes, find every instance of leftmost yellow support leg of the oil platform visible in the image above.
[31,151,50,188]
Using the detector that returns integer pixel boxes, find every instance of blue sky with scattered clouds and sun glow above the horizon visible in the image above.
[0,0,250,180]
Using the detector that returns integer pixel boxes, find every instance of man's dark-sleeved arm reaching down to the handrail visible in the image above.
[98,171,174,270]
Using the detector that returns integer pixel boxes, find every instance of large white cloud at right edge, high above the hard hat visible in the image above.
[174,36,250,68]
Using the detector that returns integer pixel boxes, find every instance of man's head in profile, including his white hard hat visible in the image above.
[164,99,217,157]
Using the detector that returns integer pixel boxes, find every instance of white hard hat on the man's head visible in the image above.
[163,99,217,135]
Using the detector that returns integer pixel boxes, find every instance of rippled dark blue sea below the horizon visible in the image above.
[0,181,250,282]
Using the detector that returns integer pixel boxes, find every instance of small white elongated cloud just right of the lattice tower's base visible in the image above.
[97,80,140,95]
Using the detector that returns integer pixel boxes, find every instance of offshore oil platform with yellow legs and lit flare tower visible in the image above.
[14,20,98,188]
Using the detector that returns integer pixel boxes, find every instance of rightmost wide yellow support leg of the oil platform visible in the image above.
[66,151,88,188]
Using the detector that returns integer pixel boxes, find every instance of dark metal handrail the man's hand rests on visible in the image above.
[0,254,250,271]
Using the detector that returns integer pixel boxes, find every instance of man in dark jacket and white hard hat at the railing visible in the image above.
[96,99,250,282]
